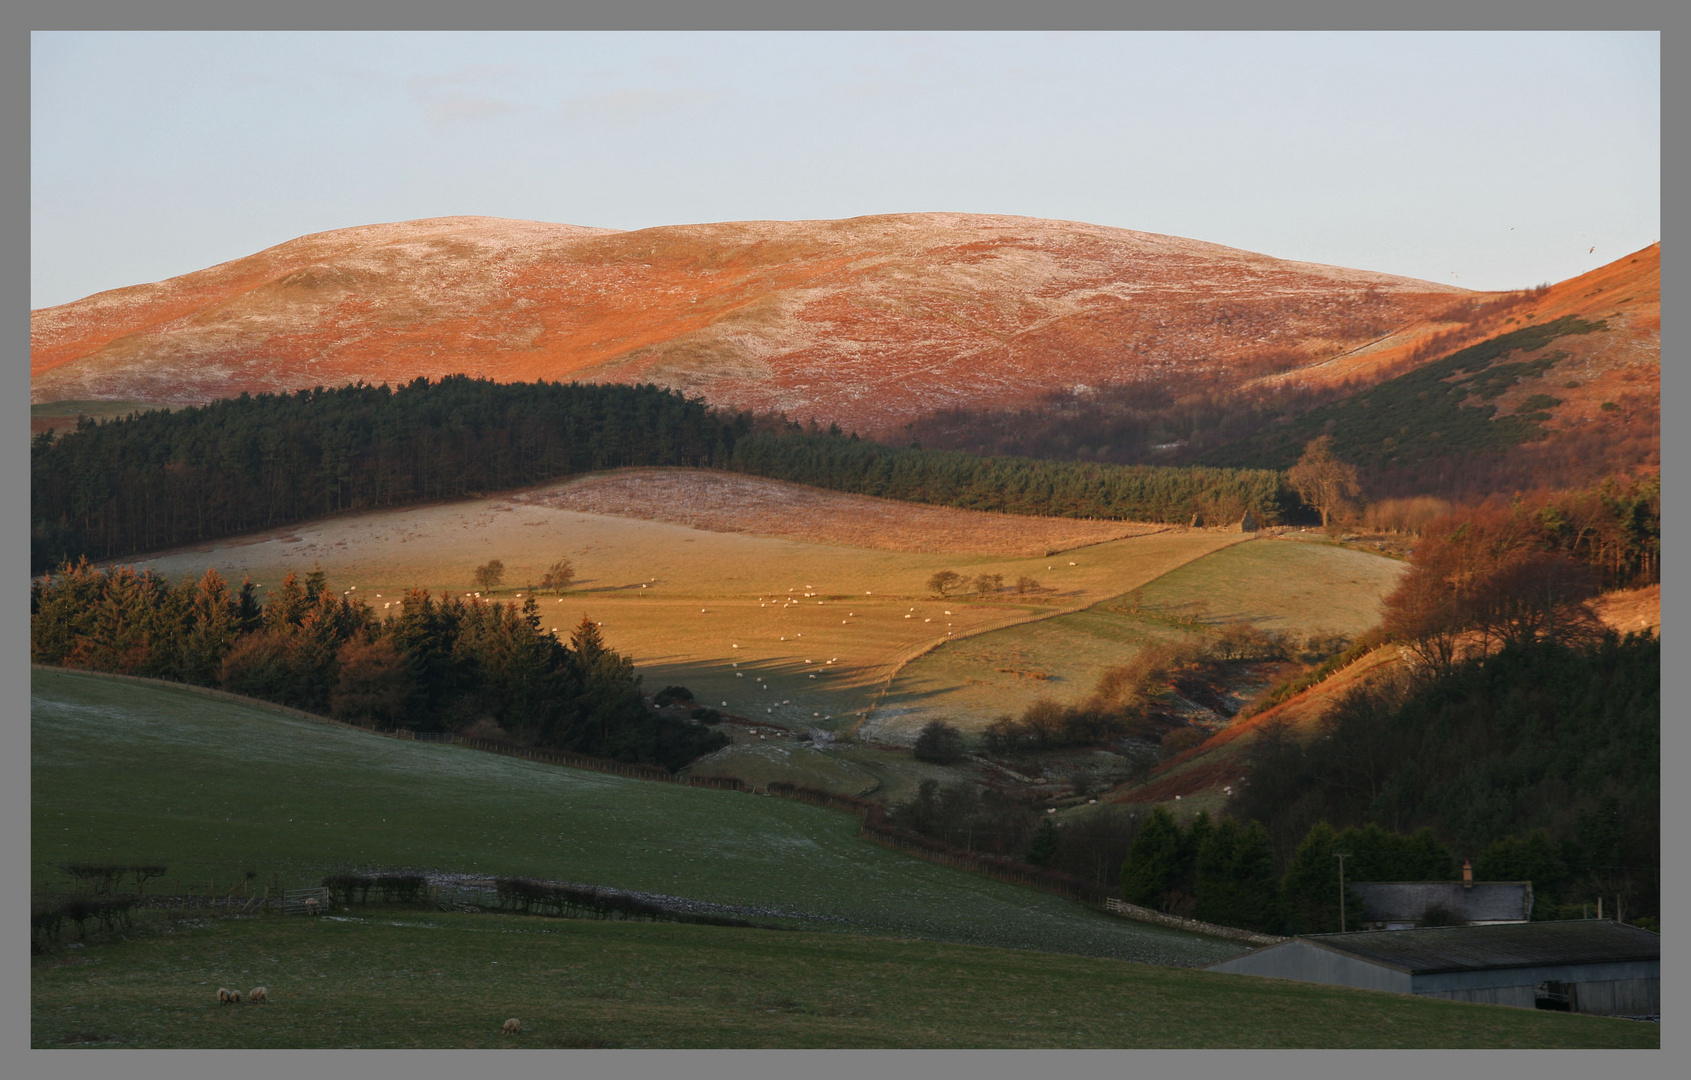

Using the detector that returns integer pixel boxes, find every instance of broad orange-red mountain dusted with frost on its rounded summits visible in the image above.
[30,213,1485,429]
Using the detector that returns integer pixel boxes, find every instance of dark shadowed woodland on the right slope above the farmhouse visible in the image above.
[1229,634,1661,914]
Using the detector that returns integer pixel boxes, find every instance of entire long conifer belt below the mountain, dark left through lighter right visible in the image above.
[30,375,1295,573]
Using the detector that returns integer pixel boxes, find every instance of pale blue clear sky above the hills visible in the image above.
[30,32,1661,309]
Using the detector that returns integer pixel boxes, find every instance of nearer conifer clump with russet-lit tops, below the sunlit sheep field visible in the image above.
[30,561,727,771]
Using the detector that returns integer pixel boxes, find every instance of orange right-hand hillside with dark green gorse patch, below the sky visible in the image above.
[1201,243,1662,494]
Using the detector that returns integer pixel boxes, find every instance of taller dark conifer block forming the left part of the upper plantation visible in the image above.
[30,375,749,573]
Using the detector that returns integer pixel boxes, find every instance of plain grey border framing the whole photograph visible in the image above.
[0,0,1691,1078]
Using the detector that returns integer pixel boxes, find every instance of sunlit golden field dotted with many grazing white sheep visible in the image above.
[128,492,1245,740]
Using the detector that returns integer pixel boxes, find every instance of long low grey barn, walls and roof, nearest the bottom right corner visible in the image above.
[1206,919,1662,1016]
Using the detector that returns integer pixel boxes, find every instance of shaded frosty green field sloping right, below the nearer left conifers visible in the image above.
[30,671,1236,963]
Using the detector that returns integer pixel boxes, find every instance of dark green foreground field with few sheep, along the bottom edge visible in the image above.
[30,909,1661,1048]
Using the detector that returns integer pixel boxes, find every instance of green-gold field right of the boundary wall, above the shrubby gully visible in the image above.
[864,539,1404,740]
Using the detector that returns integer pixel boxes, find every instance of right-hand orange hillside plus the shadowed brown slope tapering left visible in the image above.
[901,245,1661,497]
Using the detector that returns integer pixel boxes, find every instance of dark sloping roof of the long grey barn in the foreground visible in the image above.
[1302,919,1662,975]
